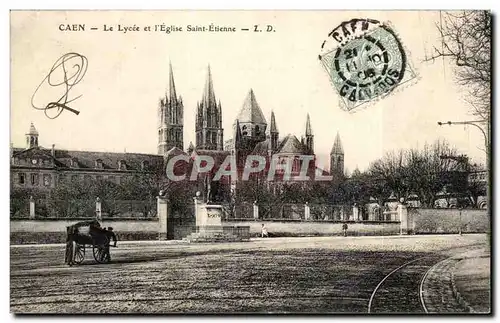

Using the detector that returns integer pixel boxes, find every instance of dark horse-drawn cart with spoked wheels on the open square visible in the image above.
[64,220,116,266]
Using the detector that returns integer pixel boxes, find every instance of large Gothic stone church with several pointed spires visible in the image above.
[158,65,344,186]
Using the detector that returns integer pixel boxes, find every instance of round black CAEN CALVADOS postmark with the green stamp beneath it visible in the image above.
[319,19,414,110]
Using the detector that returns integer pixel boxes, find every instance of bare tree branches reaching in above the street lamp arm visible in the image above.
[427,10,492,121]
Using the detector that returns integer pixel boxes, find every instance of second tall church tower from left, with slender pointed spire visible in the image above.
[195,65,224,150]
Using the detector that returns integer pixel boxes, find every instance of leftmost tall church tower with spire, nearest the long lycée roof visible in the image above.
[158,64,184,155]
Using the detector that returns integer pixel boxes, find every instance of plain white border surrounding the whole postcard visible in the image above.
[0,0,500,322]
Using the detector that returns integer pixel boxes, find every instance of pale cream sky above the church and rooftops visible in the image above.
[10,11,485,172]
